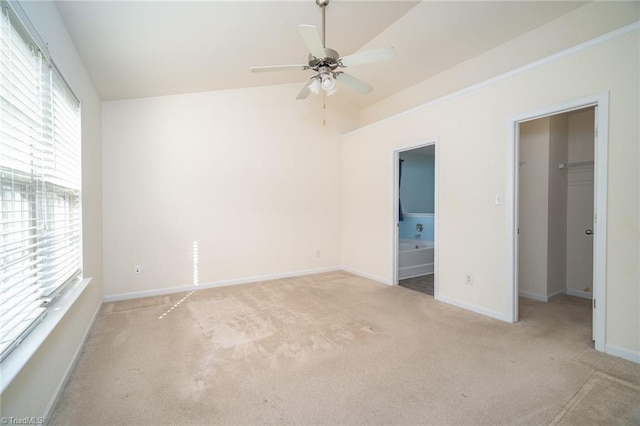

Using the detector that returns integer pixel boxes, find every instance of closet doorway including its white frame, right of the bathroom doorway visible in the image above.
[507,94,608,351]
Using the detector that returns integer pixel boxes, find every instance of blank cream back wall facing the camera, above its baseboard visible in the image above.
[102,84,357,297]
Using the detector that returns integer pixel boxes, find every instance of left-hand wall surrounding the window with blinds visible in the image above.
[0,1,103,418]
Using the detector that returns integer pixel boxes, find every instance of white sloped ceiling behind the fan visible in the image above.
[56,0,584,107]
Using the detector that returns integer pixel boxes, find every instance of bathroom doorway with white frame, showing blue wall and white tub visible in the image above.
[393,142,437,297]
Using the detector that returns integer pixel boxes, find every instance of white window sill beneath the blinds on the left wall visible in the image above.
[0,278,91,394]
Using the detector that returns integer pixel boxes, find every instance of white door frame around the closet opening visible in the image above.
[505,92,609,352]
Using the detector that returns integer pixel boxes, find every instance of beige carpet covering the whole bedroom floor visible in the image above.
[52,272,640,425]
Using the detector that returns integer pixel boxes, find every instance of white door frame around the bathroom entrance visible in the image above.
[391,138,440,300]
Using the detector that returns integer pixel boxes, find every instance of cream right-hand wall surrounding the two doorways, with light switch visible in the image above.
[342,4,640,360]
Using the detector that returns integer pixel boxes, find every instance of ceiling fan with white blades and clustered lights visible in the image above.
[251,0,396,99]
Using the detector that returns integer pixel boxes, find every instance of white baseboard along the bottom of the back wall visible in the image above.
[104,266,342,303]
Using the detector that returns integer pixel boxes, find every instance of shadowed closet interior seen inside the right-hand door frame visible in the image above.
[516,106,596,330]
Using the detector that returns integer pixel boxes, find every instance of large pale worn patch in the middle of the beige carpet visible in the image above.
[186,282,378,372]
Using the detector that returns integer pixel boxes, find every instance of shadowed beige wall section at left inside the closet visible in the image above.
[518,114,568,302]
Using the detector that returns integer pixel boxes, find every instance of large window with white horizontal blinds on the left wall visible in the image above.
[0,3,82,360]
